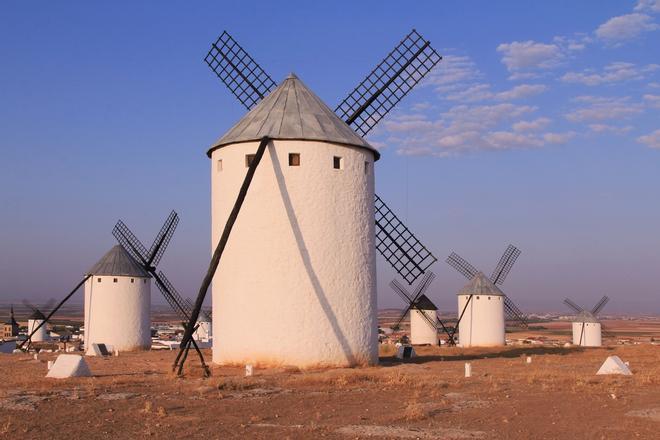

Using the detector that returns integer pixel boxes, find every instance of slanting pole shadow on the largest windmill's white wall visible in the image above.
[268,148,356,365]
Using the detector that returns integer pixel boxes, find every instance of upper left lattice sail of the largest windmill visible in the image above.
[204,31,277,110]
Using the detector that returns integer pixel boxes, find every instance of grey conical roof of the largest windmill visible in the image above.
[206,73,380,160]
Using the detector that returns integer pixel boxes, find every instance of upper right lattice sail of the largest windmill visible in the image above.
[335,29,442,136]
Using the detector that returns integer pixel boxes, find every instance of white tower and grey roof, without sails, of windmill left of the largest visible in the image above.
[85,245,151,354]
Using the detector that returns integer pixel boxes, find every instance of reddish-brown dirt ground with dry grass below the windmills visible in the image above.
[0,330,660,439]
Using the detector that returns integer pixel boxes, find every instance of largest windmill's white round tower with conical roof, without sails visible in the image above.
[207,74,379,368]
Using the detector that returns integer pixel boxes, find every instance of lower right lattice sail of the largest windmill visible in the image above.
[375,195,437,284]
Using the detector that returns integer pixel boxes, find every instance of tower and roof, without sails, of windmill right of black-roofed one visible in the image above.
[458,272,506,347]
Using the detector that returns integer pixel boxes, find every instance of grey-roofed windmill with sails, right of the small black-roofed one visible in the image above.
[447,245,527,345]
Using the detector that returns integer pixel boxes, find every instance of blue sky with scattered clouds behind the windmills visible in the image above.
[0,0,660,314]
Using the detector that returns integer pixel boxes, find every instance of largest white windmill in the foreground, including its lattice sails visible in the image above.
[176,31,440,372]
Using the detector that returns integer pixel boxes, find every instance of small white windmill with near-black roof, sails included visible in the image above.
[390,271,452,345]
